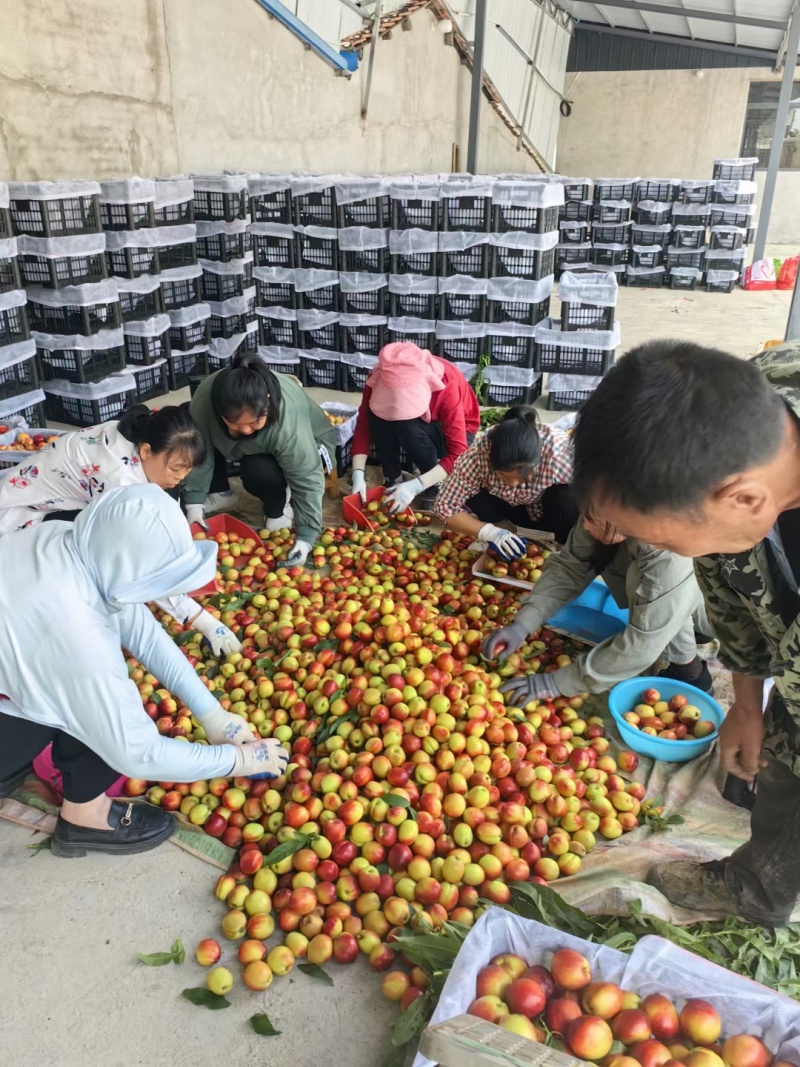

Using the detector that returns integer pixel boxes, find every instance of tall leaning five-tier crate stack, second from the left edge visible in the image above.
[9,181,135,426]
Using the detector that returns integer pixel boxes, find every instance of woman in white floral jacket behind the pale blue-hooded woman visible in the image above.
[0,404,241,656]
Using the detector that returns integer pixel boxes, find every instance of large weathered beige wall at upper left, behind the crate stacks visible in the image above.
[0,0,537,180]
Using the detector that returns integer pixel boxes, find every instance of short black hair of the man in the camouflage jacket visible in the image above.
[573,340,786,516]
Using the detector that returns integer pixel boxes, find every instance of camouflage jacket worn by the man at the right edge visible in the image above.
[694,341,800,776]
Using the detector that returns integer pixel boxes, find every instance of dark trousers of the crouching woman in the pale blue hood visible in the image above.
[0,713,119,803]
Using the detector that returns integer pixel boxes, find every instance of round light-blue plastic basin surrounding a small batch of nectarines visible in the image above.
[608,676,725,763]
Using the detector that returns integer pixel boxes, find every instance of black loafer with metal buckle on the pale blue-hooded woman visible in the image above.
[50,800,175,859]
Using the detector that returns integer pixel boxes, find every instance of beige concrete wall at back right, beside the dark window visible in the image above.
[557,67,800,244]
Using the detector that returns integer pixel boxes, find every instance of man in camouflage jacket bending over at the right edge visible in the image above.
[574,341,800,924]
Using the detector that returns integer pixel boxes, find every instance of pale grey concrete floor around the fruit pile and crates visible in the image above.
[0,264,795,1067]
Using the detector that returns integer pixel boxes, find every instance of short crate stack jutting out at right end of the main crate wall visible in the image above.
[535,271,620,411]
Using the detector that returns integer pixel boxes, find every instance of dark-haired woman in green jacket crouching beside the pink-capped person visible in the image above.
[183,354,336,567]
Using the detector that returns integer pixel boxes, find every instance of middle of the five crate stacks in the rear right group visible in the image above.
[624,178,691,288]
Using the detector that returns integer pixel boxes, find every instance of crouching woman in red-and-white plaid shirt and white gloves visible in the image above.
[434,407,578,559]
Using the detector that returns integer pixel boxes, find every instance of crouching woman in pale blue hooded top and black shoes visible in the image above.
[0,485,288,857]
